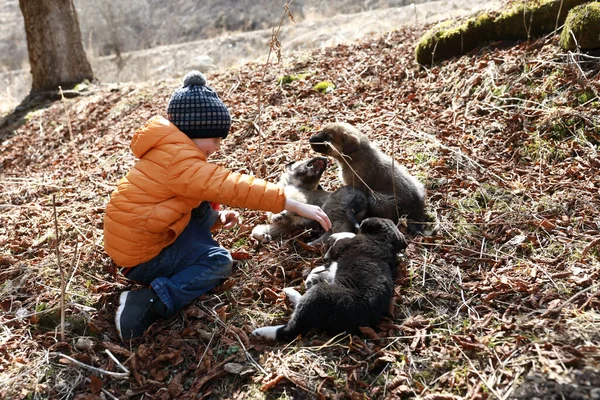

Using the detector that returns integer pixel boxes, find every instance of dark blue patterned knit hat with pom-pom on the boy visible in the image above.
[167,71,231,139]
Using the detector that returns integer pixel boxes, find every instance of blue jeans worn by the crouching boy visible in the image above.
[127,202,233,315]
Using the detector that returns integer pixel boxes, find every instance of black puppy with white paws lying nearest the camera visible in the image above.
[252,218,406,341]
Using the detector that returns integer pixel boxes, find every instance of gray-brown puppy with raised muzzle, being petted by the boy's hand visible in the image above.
[252,157,367,242]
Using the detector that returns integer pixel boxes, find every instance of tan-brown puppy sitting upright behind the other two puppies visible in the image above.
[309,123,430,233]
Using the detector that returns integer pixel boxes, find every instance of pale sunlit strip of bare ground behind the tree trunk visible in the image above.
[0,0,499,115]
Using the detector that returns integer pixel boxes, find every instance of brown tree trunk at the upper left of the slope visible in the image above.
[19,0,94,92]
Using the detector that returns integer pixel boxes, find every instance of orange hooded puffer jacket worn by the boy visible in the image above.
[104,116,286,267]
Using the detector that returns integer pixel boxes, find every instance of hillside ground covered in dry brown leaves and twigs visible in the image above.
[0,21,600,399]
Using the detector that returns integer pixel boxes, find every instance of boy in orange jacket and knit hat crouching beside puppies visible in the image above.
[104,71,331,340]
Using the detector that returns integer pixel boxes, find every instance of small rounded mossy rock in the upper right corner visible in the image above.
[560,1,600,50]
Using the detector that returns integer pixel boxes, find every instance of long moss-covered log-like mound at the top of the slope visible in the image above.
[415,0,589,65]
